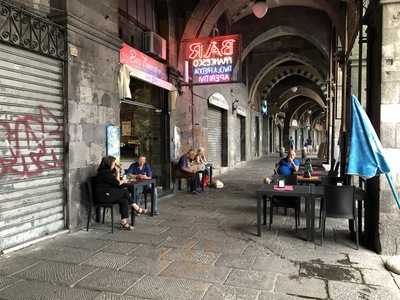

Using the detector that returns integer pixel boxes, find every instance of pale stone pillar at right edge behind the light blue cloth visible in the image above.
[379,0,400,255]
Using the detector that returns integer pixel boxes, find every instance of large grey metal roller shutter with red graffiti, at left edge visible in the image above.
[0,44,65,250]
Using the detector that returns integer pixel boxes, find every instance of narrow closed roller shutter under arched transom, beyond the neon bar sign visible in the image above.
[207,106,222,166]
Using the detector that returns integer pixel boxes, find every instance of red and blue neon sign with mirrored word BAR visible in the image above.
[185,35,240,84]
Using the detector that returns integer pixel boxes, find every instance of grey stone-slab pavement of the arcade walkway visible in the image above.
[0,159,400,300]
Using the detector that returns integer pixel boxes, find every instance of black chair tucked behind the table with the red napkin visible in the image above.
[269,175,301,232]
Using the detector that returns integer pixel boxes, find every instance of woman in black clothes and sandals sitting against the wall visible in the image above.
[93,156,145,230]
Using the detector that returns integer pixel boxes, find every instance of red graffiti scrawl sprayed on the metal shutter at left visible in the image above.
[0,106,63,177]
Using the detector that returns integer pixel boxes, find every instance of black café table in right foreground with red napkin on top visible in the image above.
[257,184,315,240]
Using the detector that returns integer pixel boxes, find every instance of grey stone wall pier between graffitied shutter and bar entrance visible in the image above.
[52,0,122,230]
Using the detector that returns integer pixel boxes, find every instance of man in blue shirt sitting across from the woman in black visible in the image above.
[126,155,159,215]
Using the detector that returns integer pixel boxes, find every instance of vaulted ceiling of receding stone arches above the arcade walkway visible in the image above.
[179,0,344,126]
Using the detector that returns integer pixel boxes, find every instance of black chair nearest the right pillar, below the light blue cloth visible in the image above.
[321,185,359,250]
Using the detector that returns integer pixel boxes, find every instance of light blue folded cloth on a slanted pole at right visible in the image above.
[346,96,400,208]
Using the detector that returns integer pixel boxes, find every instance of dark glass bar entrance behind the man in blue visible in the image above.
[120,78,170,192]
